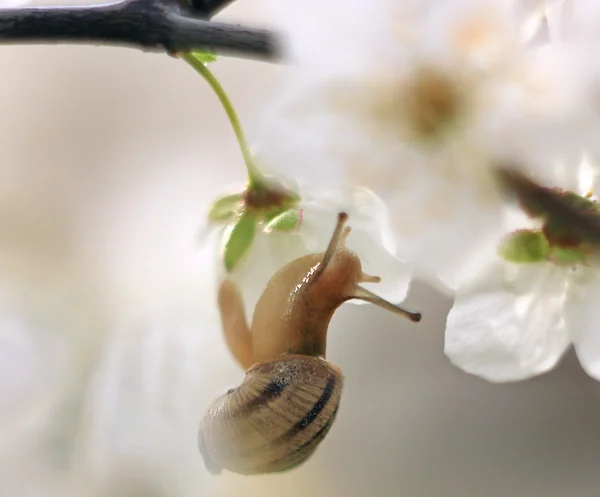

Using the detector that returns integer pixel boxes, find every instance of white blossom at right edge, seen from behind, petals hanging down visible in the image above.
[445,162,600,382]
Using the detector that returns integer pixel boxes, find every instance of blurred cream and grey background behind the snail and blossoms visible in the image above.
[0,0,600,497]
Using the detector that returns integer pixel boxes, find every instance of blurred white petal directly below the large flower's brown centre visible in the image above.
[376,145,505,289]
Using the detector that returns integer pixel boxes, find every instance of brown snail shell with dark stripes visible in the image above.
[198,354,343,475]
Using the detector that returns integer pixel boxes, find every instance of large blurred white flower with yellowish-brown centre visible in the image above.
[263,0,587,287]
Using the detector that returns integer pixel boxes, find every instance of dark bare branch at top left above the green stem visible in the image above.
[0,0,279,60]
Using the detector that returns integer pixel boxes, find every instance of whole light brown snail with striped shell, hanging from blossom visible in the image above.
[198,213,421,475]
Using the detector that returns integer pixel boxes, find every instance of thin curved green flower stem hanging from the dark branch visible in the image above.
[181,53,265,189]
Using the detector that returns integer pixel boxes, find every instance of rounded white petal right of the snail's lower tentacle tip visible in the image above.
[445,261,570,382]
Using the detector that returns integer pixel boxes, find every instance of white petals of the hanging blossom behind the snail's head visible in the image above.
[207,181,413,316]
